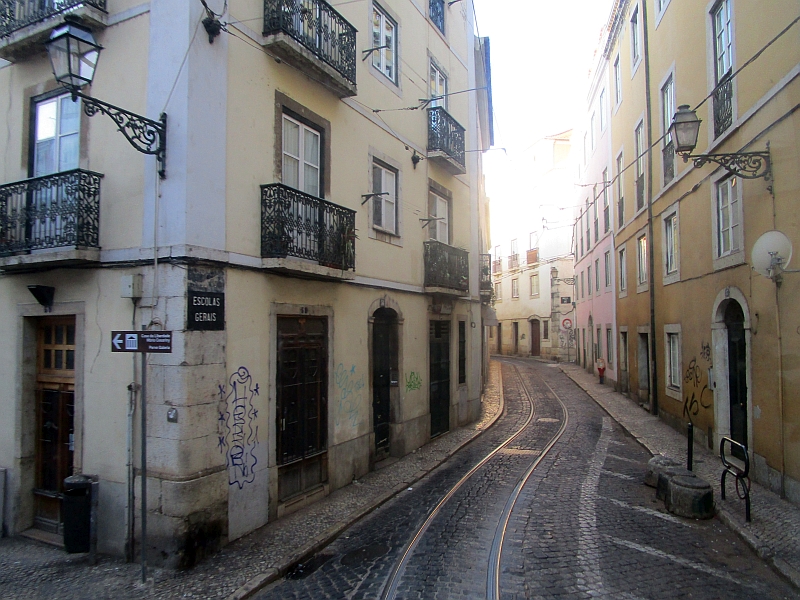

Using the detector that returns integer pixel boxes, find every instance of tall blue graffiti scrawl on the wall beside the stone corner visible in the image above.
[218,367,259,489]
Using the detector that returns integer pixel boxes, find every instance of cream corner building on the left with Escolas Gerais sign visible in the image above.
[0,0,492,565]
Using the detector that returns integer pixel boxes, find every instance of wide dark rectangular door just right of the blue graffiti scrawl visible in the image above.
[276,317,328,502]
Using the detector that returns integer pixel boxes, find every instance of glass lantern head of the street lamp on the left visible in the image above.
[46,21,103,90]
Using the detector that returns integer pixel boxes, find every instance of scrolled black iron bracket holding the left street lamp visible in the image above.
[69,89,167,179]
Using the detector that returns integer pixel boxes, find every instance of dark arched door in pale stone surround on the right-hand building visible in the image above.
[725,300,747,458]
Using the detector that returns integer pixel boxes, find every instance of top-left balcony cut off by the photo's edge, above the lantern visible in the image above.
[0,0,108,62]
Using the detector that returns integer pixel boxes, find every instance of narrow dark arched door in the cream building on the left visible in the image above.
[372,308,398,460]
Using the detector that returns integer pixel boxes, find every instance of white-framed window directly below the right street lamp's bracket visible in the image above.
[711,173,745,270]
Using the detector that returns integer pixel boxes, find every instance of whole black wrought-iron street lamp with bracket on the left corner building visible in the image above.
[46,16,167,179]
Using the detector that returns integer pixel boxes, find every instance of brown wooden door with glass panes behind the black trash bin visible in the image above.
[33,317,75,533]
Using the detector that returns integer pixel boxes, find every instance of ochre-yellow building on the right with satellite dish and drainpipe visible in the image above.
[604,0,800,502]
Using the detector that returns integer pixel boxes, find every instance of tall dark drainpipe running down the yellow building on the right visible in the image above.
[641,0,658,415]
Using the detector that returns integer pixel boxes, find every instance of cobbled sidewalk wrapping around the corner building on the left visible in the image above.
[0,361,503,600]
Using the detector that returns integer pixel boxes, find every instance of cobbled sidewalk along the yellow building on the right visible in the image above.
[559,363,800,589]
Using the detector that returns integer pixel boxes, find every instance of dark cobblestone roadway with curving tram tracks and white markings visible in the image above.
[257,361,794,600]
